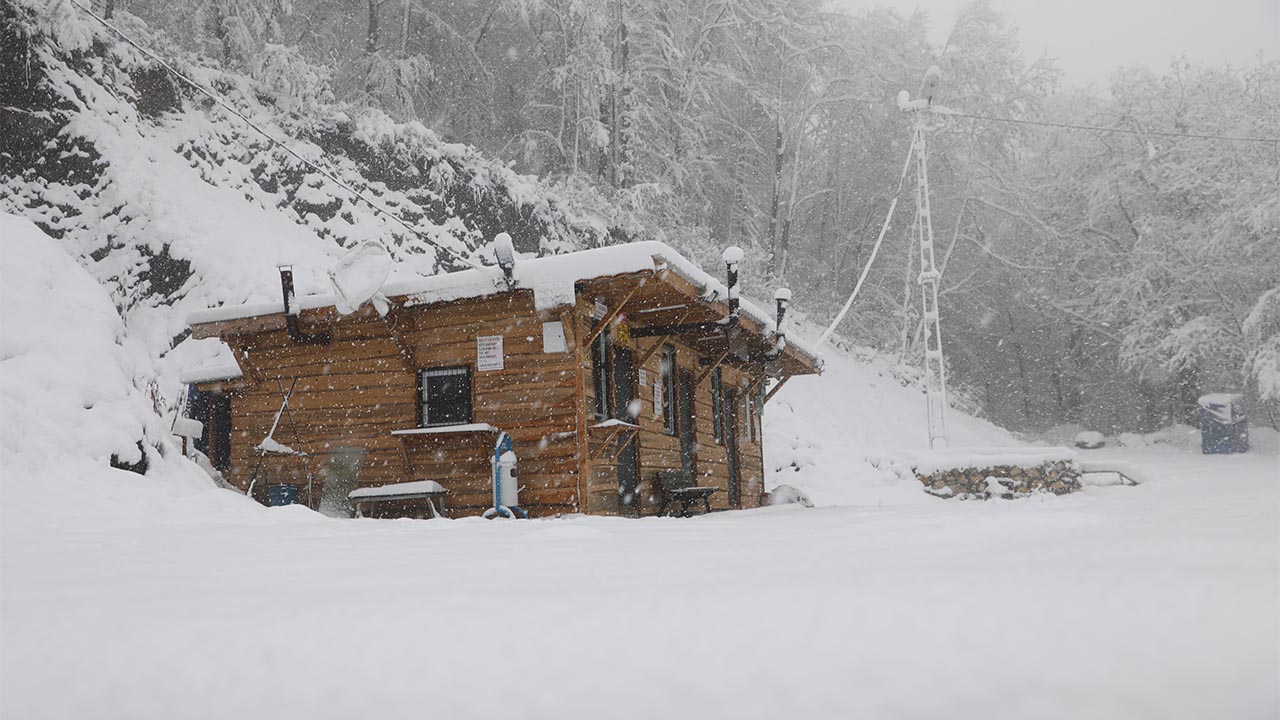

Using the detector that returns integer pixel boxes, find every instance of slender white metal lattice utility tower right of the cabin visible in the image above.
[911,105,950,448]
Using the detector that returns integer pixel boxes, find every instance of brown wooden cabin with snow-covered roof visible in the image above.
[183,242,822,516]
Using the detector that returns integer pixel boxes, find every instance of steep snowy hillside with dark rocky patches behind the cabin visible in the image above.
[0,0,609,381]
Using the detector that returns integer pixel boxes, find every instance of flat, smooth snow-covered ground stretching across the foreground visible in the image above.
[0,448,1280,720]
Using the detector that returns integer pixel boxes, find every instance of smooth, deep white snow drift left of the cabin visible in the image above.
[0,213,257,530]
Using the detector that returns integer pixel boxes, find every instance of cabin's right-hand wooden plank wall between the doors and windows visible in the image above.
[576,299,764,515]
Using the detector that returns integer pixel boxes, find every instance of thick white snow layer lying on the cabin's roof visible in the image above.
[187,241,822,366]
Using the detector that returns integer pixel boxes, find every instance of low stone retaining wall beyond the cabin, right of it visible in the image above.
[915,460,1080,500]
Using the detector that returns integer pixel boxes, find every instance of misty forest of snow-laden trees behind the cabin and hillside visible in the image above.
[17,0,1280,430]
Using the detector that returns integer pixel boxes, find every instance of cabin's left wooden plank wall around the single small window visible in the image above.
[213,291,580,516]
